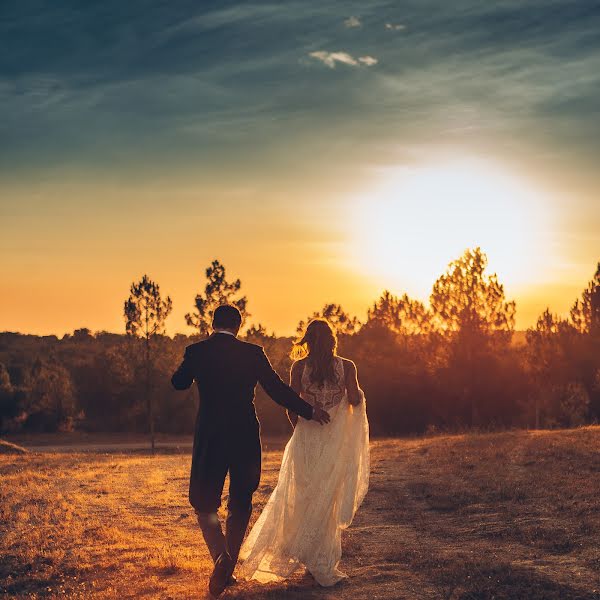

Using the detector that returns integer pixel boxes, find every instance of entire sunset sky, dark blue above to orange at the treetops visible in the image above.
[0,0,600,335]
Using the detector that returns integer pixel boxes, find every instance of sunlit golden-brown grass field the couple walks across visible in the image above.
[0,427,600,600]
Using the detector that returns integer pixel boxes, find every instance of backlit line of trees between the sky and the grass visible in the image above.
[0,248,600,440]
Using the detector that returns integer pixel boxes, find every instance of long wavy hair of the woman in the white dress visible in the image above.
[291,319,337,387]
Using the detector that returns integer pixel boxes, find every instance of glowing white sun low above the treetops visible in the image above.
[348,160,549,297]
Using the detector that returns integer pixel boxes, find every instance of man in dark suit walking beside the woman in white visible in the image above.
[171,305,329,596]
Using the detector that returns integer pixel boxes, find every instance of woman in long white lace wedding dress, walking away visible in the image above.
[240,319,369,586]
